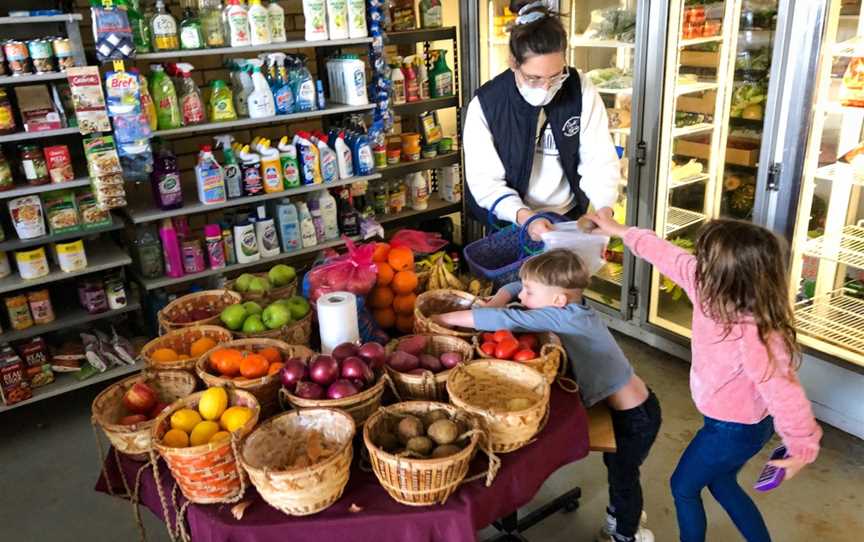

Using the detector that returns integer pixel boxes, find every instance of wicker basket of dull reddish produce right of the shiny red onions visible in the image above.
[386,335,474,401]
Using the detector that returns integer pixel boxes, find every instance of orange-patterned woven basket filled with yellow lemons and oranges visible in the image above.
[151,388,261,504]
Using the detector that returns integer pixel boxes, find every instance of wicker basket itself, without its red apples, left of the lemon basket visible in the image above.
[90,370,197,461]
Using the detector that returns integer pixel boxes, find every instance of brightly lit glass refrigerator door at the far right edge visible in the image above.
[790,0,864,366]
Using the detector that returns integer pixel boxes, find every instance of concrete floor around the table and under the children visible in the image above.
[0,337,864,542]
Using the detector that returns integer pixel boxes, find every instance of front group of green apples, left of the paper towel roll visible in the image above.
[219,295,312,346]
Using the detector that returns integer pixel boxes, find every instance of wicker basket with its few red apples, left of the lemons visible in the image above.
[91,371,196,461]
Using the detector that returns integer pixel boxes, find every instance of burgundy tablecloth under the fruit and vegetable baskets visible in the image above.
[96,386,588,542]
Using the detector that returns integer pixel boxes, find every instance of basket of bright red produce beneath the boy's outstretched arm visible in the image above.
[474,329,567,383]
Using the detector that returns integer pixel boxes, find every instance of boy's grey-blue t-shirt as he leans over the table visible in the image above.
[471,282,633,407]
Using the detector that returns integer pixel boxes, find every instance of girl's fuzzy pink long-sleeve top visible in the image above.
[624,228,822,463]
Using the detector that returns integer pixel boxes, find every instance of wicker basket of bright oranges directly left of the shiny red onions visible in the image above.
[196,339,313,416]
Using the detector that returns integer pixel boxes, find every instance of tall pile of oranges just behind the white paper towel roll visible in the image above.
[366,243,420,333]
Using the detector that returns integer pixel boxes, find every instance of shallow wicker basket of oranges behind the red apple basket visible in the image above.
[139,325,233,375]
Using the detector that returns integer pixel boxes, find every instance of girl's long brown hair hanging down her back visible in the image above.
[696,219,801,379]
